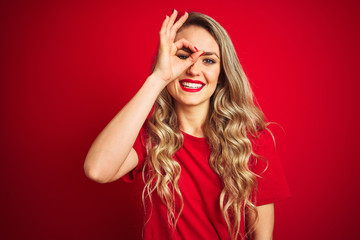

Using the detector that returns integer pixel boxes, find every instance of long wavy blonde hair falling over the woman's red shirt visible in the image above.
[142,12,267,239]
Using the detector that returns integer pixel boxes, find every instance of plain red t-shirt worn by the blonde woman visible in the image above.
[123,123,290,240]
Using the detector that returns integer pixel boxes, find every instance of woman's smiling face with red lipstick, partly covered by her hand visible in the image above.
[167,25,220,107]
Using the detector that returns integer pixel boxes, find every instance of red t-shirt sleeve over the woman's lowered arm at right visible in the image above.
[250,130,291,206]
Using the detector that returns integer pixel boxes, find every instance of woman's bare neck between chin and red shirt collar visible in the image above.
[175,103,209,137]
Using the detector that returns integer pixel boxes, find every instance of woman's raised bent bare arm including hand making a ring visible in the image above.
[84,11,202,183]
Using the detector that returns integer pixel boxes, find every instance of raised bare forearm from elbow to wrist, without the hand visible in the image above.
[84,75,166,182]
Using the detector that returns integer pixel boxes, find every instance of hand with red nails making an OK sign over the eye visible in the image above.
[153,10,203,84]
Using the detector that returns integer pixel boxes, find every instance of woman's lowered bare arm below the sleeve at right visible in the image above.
[247,203,274,240]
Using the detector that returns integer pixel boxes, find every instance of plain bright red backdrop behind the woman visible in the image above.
[0,0,360,239]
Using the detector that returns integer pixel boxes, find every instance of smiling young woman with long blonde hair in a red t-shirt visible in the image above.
[84,10,289,240]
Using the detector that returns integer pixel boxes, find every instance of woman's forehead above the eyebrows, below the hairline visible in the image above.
[175,25,220,56]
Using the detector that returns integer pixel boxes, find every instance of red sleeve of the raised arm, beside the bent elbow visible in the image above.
[122,121,147,183]
